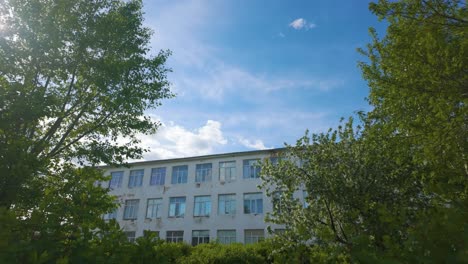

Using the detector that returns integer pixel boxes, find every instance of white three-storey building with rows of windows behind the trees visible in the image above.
[103,149,303,245]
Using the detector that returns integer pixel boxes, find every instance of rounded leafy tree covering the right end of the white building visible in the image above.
[263,120,427,261]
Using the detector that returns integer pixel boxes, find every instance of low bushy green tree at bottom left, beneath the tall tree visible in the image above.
[0,165,128,263]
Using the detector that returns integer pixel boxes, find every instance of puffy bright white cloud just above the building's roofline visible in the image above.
[134,120,227,160]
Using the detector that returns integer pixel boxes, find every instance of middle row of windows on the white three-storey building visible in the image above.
[104,193,263,220]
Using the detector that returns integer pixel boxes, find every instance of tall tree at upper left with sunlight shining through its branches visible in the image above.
[0,0,172,207]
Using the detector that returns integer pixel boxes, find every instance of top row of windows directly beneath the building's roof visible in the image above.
[109,159,260,189]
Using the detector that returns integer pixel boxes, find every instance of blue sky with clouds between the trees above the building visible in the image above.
[137,0,385,159]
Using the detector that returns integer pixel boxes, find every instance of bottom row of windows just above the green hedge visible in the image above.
[125,229,265,246]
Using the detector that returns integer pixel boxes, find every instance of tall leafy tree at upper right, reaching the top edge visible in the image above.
[360,0,468,207]
